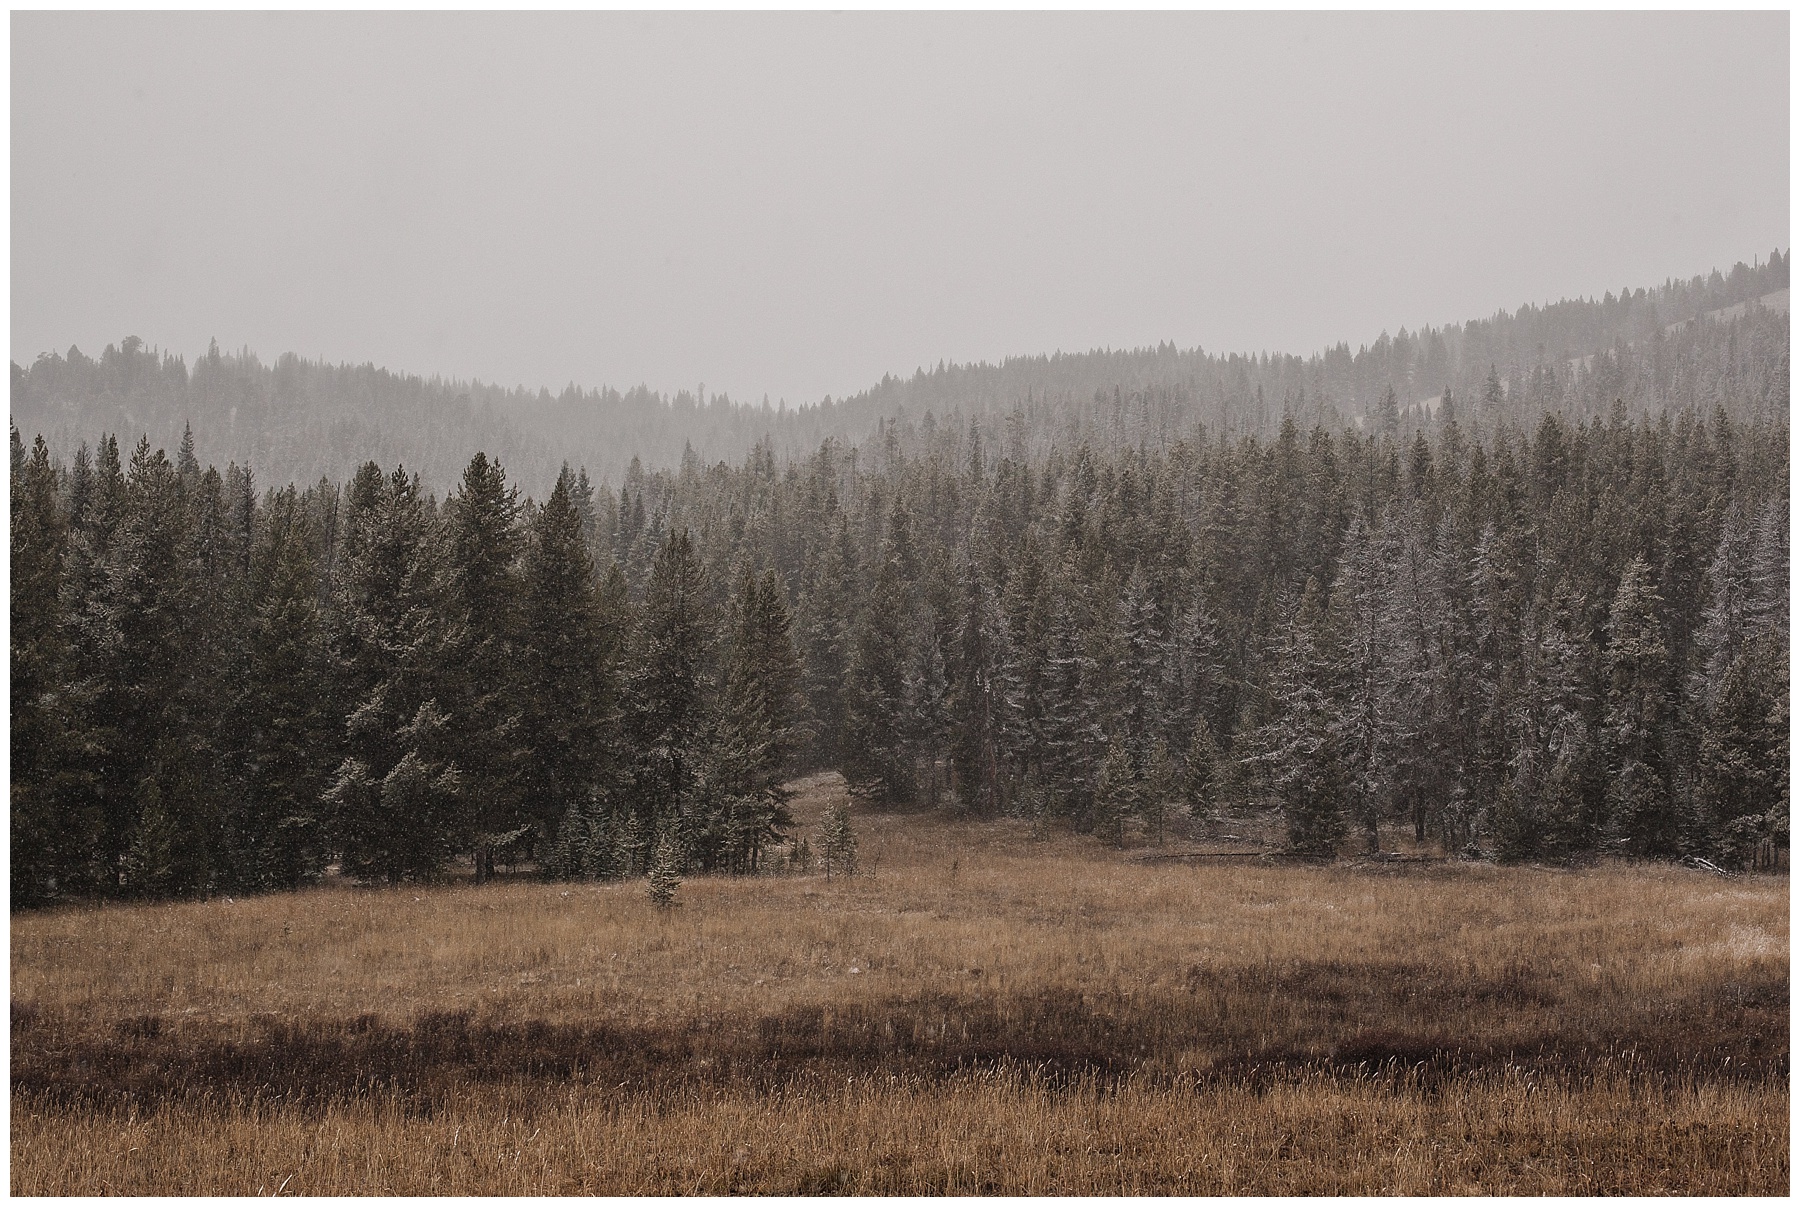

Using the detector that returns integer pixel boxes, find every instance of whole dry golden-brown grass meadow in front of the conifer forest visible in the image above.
[11,775,1787,1194]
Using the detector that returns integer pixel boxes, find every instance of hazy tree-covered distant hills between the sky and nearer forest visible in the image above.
[13,252,1787,496]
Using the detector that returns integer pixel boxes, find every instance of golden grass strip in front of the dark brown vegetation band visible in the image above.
[13,1072,1787,1194]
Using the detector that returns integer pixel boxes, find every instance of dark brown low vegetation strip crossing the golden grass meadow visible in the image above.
[13,962,1787,1106]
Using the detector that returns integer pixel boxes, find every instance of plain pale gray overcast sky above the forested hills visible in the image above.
[13,13,1789,403]
